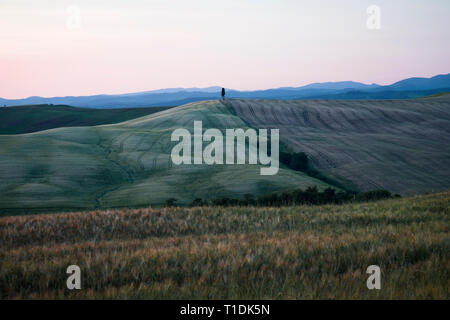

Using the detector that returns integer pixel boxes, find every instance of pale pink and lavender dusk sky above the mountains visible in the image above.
[0,0,450,98]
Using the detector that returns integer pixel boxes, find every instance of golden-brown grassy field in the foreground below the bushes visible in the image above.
[0,192,450,299]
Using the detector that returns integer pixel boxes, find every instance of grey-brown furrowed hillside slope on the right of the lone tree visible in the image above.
[230,96,450,195]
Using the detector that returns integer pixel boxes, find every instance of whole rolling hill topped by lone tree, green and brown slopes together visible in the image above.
[0,96,450,212]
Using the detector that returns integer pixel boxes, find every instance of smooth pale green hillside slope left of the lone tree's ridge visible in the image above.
[0,101,327,212]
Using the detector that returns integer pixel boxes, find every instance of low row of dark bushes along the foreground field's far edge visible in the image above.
[166,186,399,207]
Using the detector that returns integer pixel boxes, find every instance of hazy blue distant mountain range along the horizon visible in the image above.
[0,74,450,108]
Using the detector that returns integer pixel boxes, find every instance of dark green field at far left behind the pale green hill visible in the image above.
[0,105,174,134]
